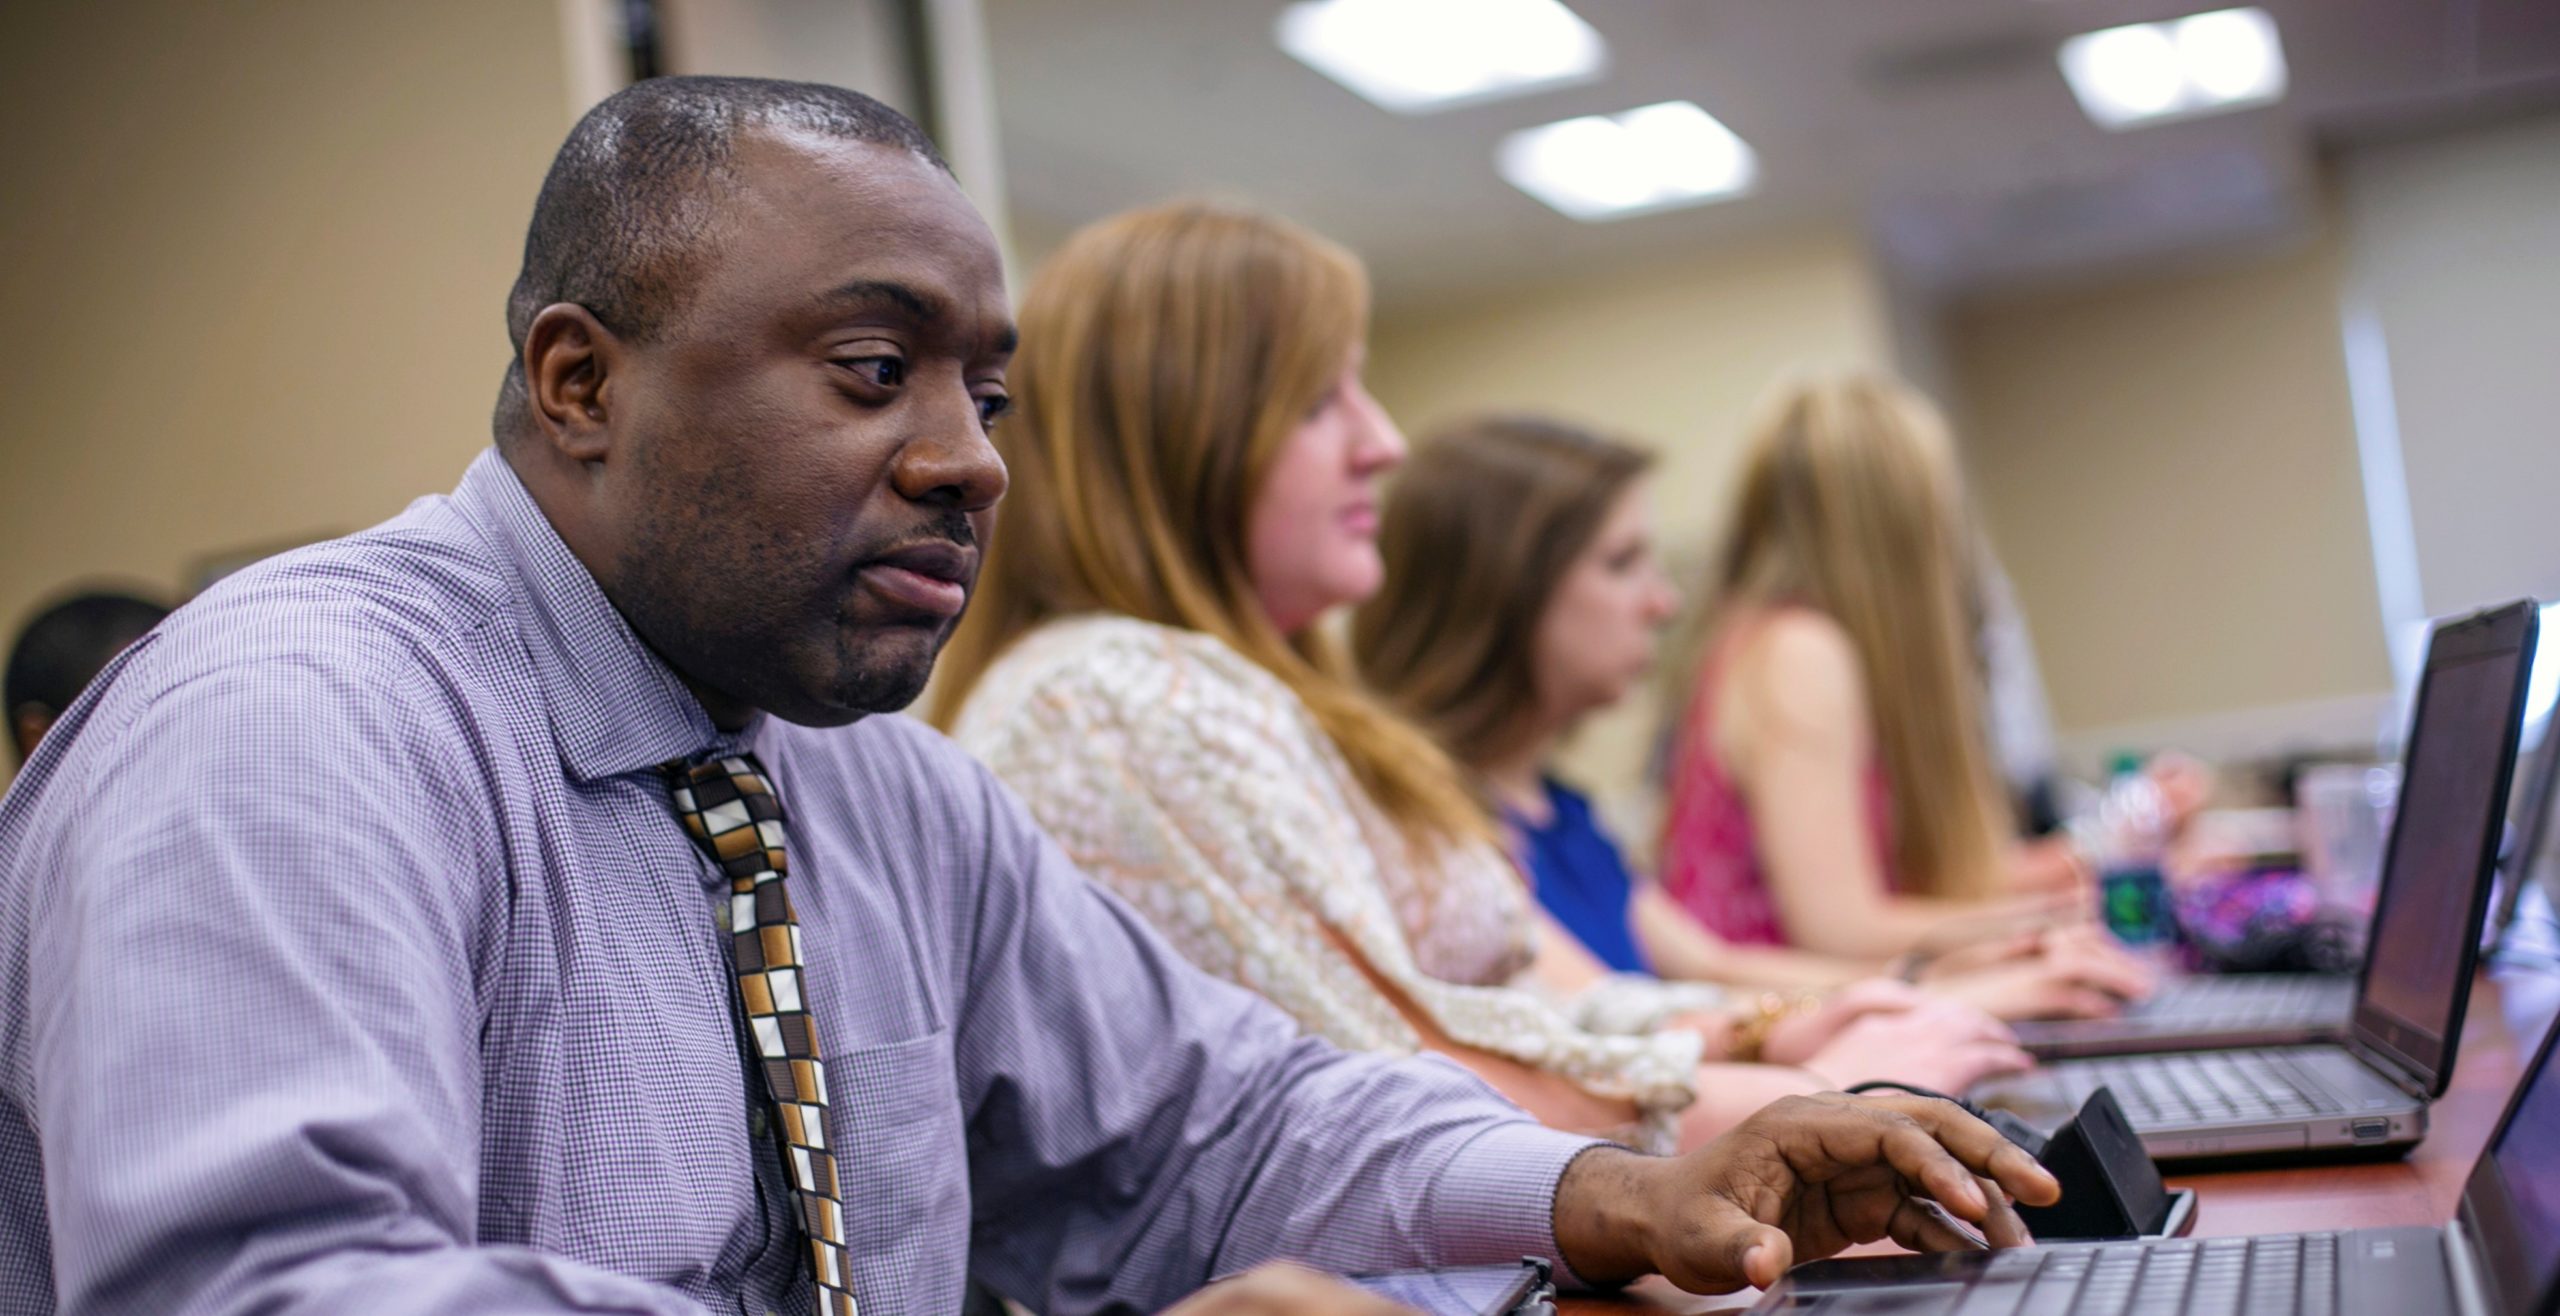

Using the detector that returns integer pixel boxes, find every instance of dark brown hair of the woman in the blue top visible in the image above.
[1352,415,1654,763]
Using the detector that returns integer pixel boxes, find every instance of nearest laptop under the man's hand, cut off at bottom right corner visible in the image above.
[1751,993,2560,1316]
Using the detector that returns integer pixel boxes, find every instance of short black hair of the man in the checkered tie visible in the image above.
[497,77,950,438]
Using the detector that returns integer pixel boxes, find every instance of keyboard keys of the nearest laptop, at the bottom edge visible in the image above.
[1953,1234,2337,1316]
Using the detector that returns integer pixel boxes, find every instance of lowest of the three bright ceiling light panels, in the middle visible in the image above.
[1495,100,1759,223]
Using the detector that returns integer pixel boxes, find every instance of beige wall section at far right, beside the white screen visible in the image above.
[1948,233,2391,748]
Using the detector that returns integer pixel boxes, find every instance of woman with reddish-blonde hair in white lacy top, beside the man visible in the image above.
[934,205,2022,1144]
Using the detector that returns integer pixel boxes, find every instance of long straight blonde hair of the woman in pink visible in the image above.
[1690,374,2012,896]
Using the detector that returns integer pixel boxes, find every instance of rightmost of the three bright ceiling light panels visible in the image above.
[2061,8,2284,128]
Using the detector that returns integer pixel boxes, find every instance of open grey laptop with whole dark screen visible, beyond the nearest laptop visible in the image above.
[1969,604,2540,1160]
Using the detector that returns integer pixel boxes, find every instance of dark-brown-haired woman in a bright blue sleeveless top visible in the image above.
[1352,417,2148,1019]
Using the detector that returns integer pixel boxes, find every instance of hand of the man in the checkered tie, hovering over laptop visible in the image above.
[1554,1093,2061,1293]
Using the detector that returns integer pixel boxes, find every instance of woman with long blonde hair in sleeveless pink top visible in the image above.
[1659,374,2086,960]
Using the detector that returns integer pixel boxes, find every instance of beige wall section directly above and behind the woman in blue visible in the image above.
[1370,233,1892,837]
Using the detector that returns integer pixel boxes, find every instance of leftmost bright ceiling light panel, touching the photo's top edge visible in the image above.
[1275,0,1608,115]
